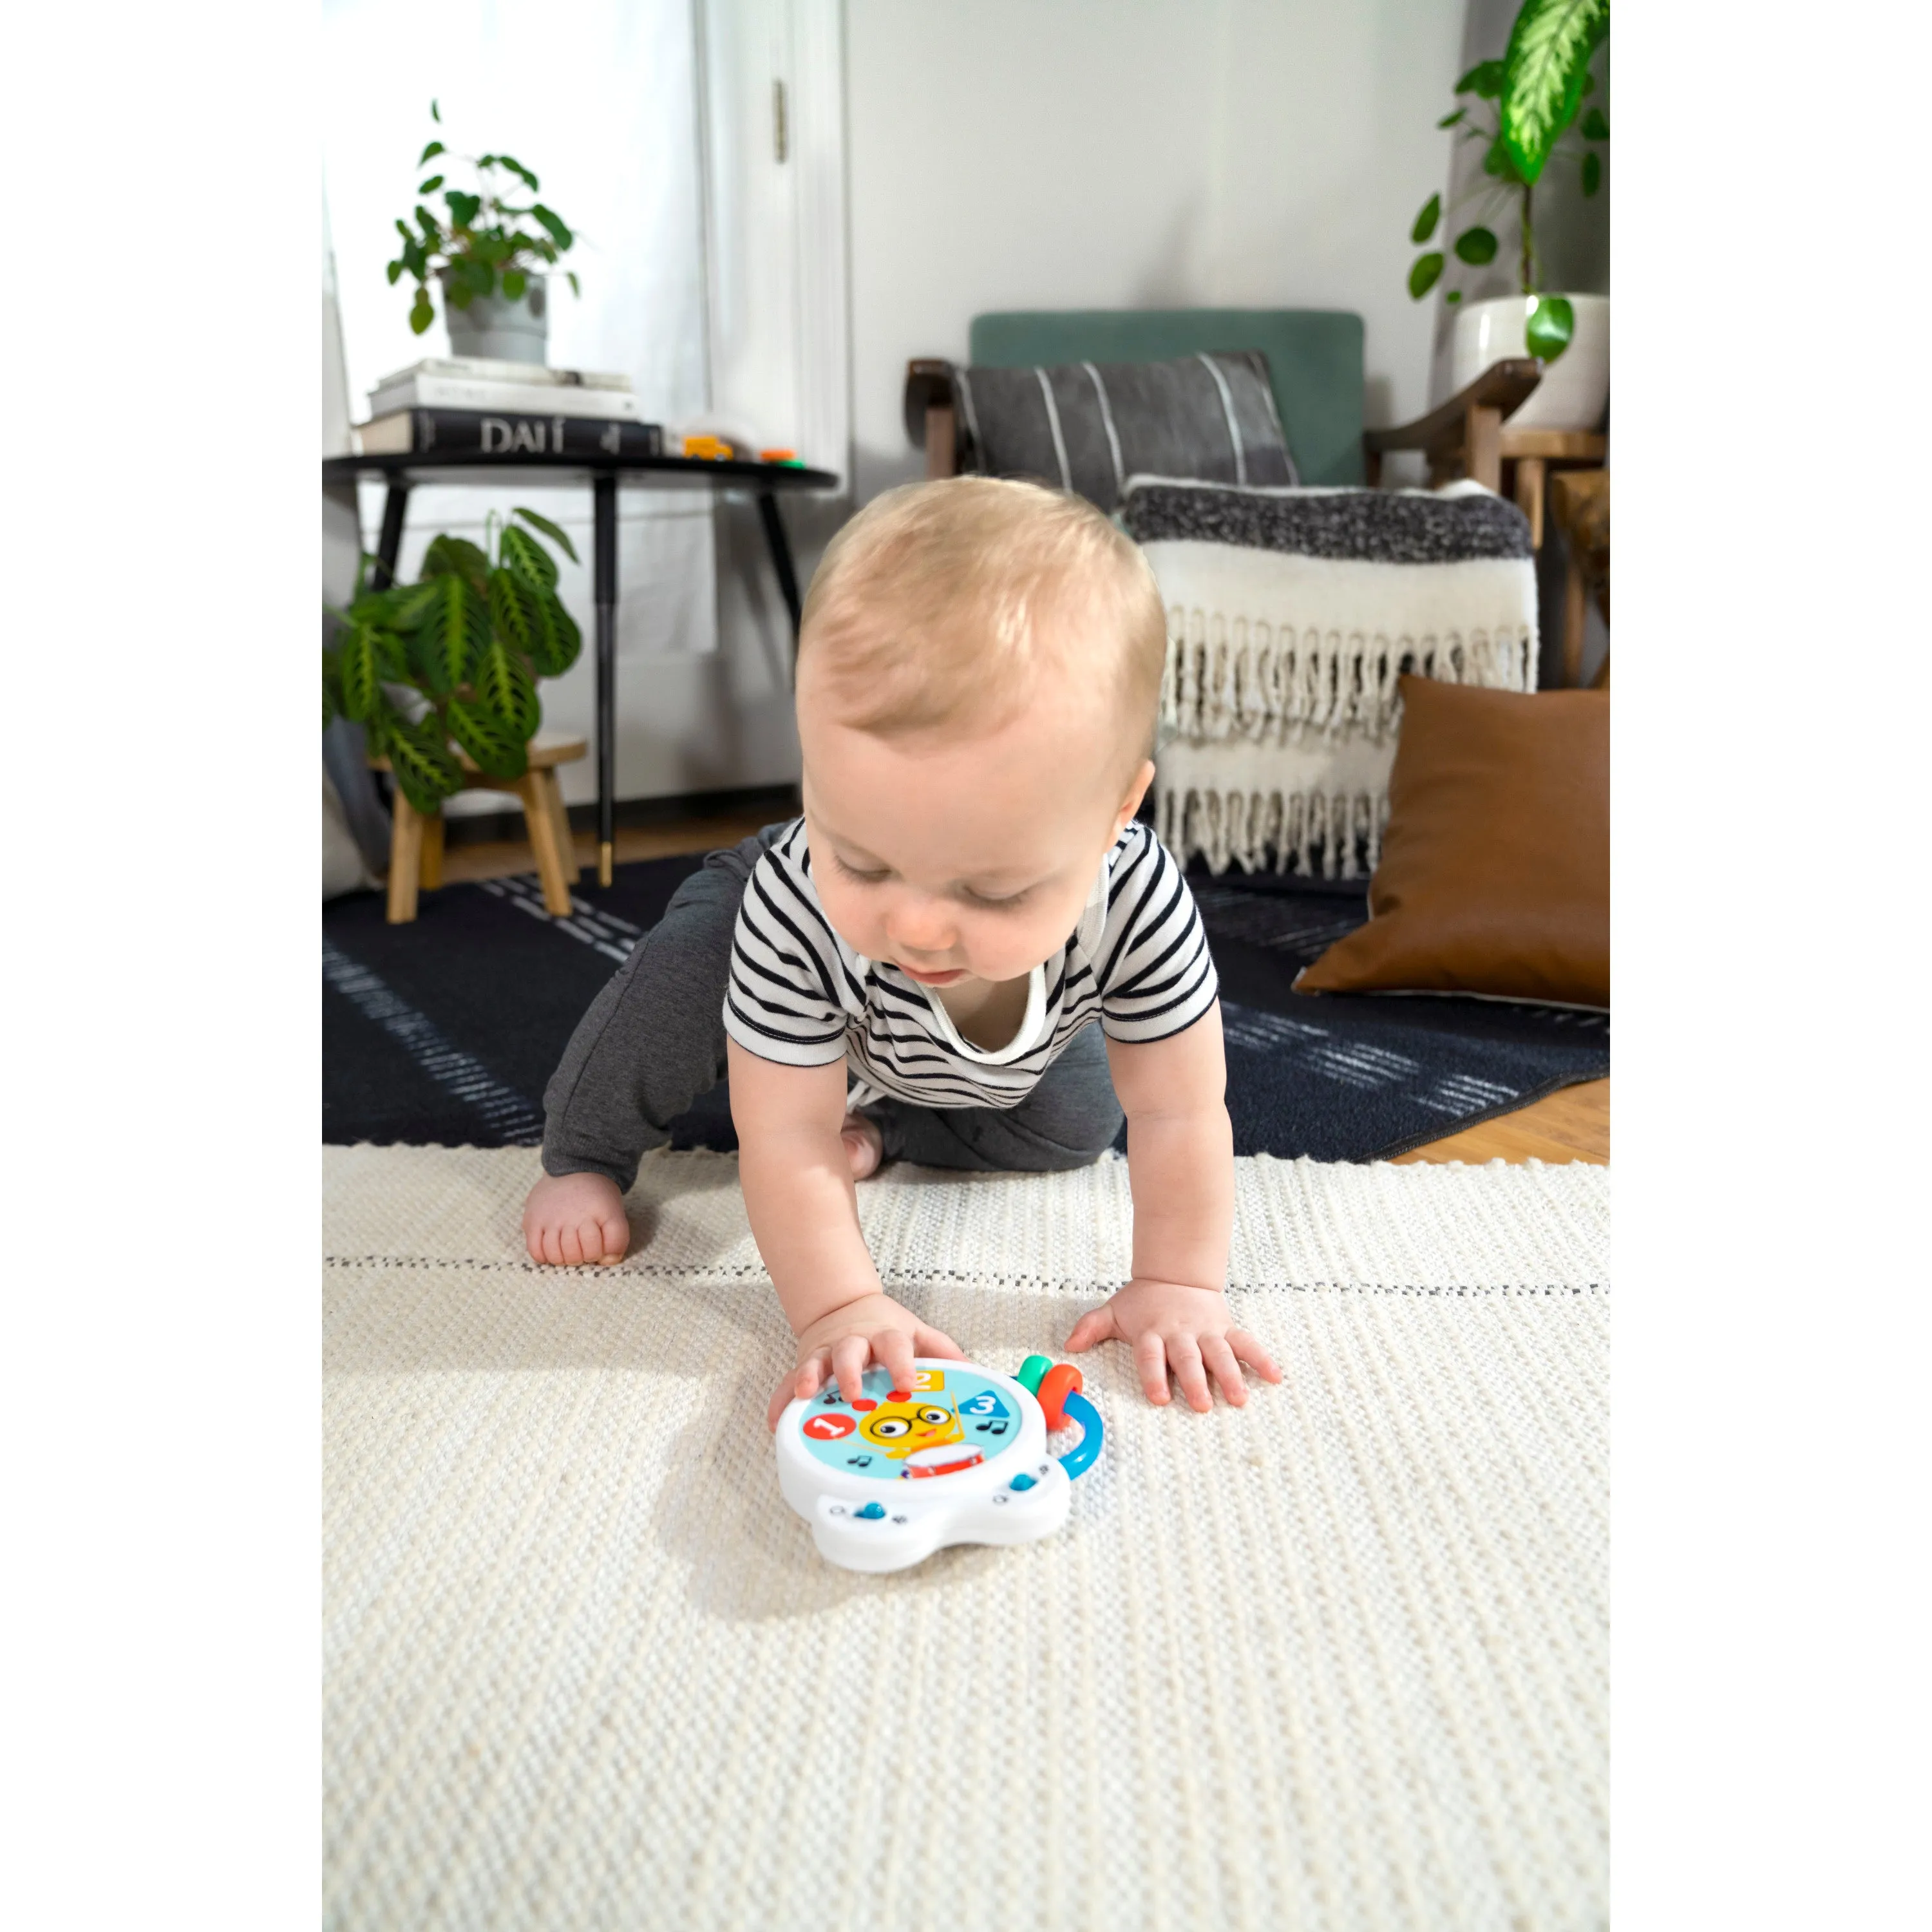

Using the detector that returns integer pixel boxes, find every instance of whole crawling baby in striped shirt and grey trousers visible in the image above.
[524,477,1281,1426]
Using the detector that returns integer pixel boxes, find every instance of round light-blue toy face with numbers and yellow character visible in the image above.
[796,1366,1020,1482]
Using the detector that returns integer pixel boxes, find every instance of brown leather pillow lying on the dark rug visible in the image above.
[1294,678,1609,1007]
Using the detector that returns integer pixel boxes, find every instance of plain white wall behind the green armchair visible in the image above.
[846,0,1463,498]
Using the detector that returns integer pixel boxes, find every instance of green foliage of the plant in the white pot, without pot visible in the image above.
[1408,0,1609,363]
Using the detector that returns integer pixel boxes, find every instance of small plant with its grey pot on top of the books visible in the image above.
[388,100,582,363]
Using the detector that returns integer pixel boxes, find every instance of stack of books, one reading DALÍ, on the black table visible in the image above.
[355,355,665,464]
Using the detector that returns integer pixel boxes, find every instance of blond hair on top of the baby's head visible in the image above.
[798,477,1167,759]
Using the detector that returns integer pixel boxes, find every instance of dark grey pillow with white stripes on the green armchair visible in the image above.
[952,350,1296,510]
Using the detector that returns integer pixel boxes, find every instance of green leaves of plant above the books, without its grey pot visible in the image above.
[388,100,582,334]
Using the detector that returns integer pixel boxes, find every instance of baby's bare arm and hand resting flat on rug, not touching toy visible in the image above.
[1066,1001,1281,1410]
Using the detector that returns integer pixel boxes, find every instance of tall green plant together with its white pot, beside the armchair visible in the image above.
[1408,0,1609,429]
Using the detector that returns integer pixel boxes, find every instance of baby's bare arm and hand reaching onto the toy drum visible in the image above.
[726,1039,962,1428]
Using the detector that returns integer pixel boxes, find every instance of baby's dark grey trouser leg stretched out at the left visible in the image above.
[543,825,784,1188]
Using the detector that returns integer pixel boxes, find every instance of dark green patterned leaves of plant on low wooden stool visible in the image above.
[323,510,583,813]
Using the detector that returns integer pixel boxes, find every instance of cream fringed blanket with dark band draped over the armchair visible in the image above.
[1121,477,1536,879]
